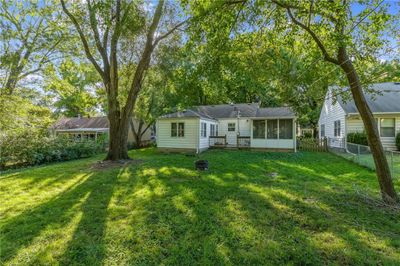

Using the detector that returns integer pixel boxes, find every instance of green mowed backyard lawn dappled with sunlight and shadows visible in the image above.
[0,149,400,265]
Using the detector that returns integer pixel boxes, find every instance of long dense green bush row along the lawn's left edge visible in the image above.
[0,131,103,169]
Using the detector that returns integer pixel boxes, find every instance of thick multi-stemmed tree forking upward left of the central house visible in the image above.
[61,0,183,160]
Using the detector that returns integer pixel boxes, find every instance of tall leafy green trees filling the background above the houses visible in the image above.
[0,0,400,202]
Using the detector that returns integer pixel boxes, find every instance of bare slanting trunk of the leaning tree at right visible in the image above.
[338,48,398,203]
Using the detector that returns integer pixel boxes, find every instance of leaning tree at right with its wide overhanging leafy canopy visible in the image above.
[186,0,399,203]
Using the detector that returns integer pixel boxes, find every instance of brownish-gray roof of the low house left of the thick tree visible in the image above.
[52,116,108,130]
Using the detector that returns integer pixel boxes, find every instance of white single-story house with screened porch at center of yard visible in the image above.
[156,103,296,153]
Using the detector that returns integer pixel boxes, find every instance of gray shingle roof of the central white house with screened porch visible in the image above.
[160,103,295,119]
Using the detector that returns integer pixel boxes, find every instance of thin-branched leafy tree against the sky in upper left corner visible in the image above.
[0,0,66,95]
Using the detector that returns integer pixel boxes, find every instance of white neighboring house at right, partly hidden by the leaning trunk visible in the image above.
[318,82,400,150]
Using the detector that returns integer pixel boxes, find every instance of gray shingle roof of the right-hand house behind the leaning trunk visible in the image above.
[338,82,400,113]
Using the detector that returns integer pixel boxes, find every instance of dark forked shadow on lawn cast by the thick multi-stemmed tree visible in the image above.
[0,166,123,264]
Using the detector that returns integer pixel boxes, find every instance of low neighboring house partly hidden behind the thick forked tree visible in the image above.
[50,116,152,145]
